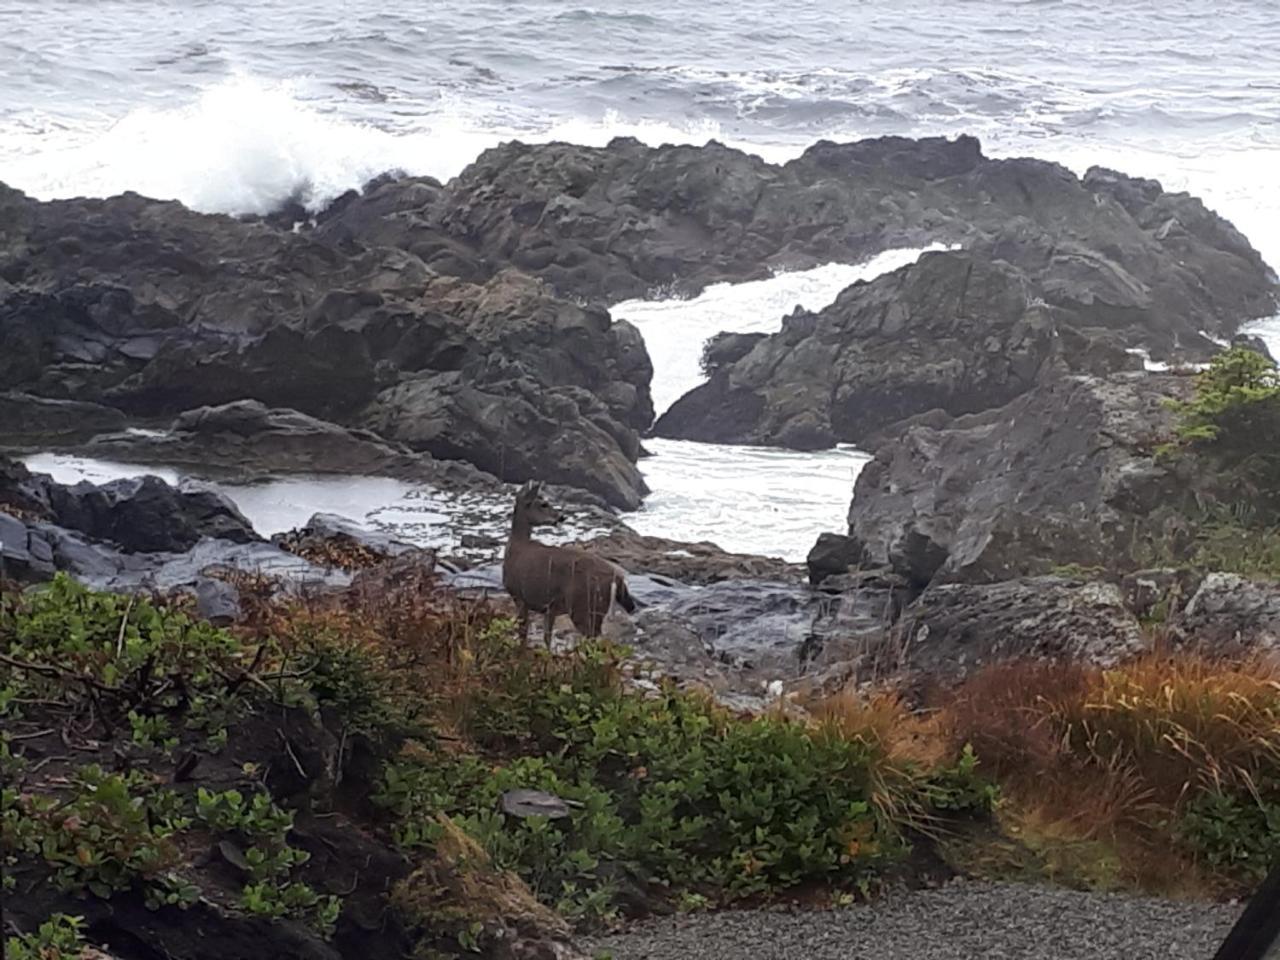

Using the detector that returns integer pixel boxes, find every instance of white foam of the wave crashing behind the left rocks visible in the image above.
[0,74,778,214]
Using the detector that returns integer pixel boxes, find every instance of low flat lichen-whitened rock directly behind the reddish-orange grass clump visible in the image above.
[901,577,1144,676]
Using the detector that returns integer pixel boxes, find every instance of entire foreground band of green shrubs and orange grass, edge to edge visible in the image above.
[0,568,1280,957]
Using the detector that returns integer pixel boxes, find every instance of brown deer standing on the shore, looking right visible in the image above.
[502,480,636,650]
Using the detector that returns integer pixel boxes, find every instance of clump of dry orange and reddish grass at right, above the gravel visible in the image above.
[940,653,1280,896]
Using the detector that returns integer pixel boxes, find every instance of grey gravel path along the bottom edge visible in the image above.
[588,882,1243,960]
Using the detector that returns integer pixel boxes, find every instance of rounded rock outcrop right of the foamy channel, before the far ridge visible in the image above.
[654,252,1111,449]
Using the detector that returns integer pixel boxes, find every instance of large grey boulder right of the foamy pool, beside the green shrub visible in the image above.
[849,374,1197,586]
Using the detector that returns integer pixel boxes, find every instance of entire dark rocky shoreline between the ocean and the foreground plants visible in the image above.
[0,137,1280,956]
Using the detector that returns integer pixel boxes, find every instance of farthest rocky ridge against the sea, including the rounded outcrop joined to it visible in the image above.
[307,137,1276,460]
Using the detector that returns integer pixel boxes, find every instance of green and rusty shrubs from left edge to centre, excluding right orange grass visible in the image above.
[0,577,995,946]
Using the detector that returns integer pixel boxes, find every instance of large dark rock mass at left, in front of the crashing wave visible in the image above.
[0,187,653,507]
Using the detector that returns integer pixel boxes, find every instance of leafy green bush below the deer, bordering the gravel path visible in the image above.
[378,644,991,915]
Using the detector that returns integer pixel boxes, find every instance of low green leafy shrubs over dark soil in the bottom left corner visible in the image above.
[0,576,340,933]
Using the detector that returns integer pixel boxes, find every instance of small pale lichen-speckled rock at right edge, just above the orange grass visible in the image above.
[1179,573,1280,653]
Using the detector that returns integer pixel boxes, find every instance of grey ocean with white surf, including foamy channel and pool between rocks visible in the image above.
[0,0,1280,557]
